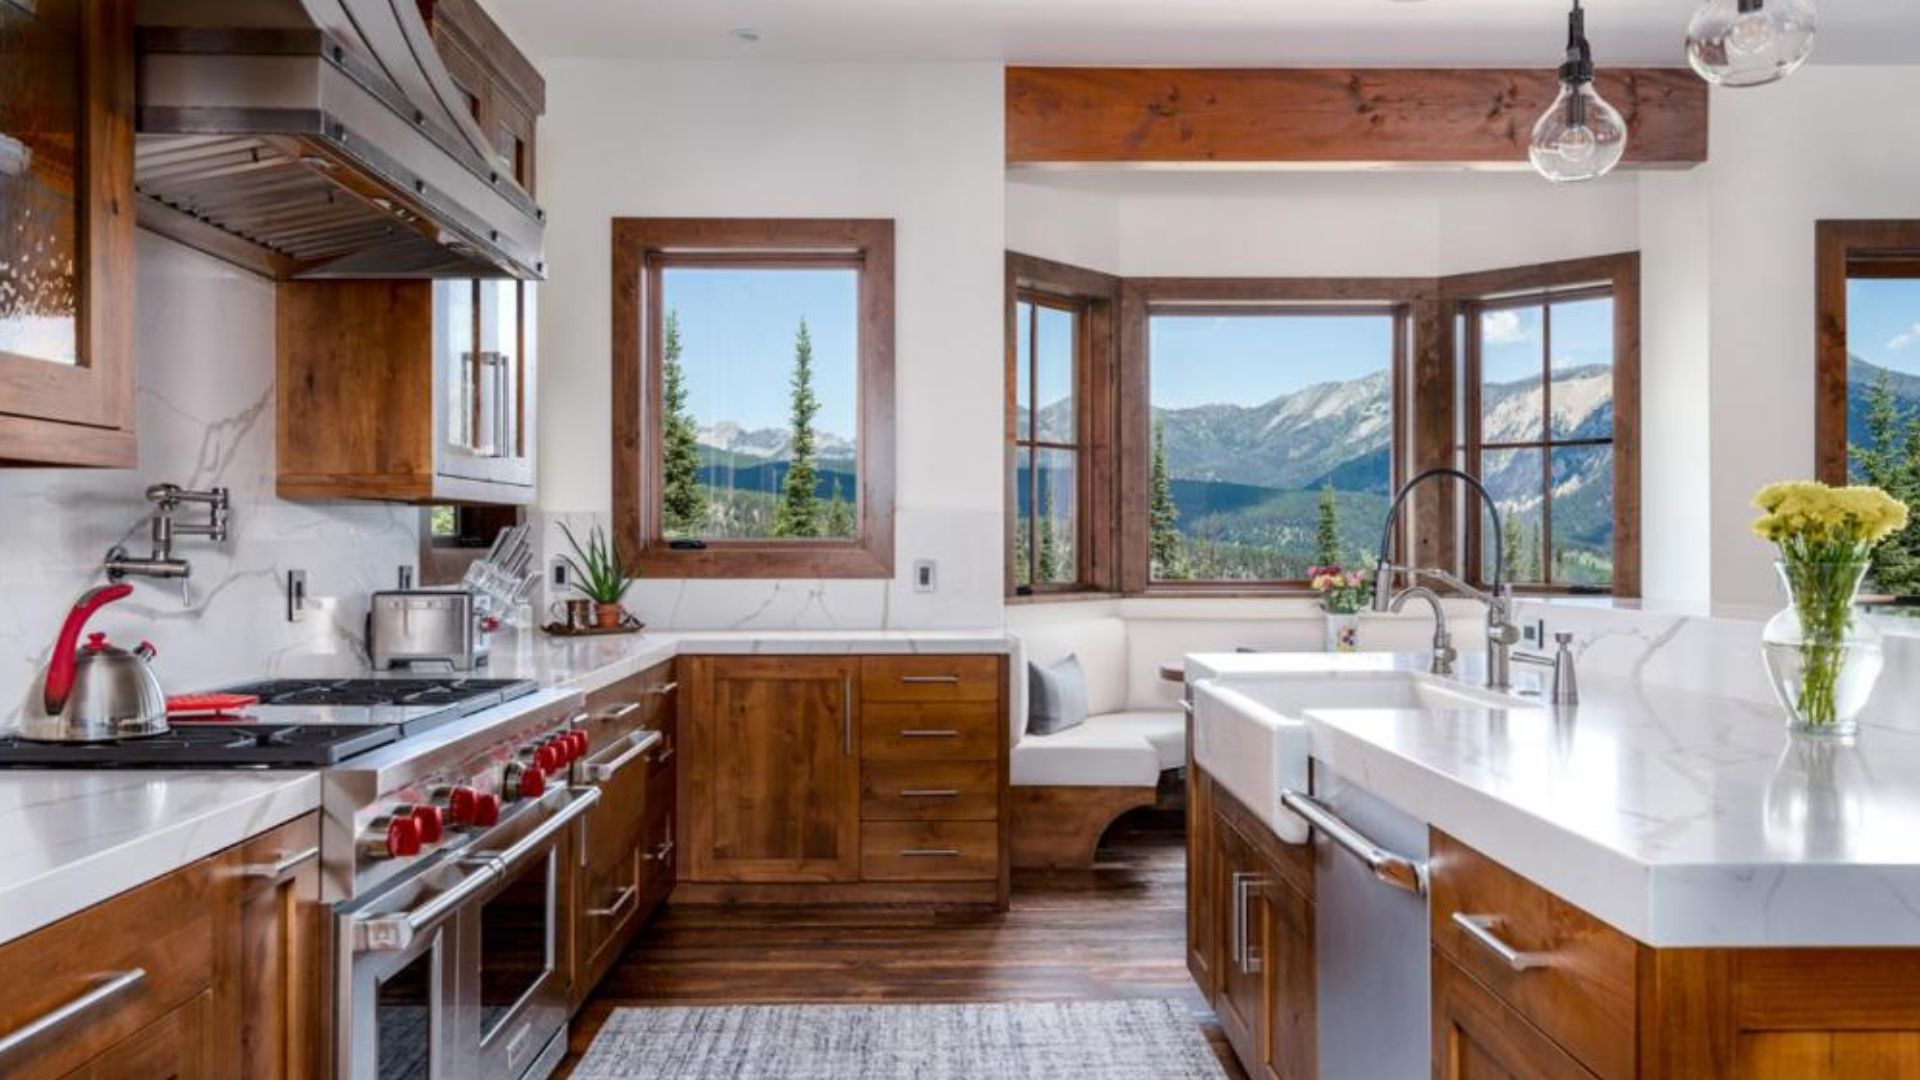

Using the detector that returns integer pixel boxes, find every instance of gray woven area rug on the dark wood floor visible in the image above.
[574,1001,1227,1080]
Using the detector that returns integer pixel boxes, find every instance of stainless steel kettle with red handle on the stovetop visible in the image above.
[19,584,167,742]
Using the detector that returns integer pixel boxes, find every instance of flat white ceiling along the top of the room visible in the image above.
[484,0,1920,67]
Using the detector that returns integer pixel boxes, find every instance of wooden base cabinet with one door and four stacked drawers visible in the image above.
[680,655,1008,905]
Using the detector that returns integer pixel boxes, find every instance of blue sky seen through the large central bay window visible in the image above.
[1146,313,1394,409]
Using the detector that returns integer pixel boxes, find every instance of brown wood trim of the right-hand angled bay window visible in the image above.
[1440,252,1643,598]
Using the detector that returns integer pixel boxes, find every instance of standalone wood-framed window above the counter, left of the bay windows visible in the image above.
[612,217,895,578]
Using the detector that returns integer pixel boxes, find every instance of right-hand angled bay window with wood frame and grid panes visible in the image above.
[1442,254,1640,596]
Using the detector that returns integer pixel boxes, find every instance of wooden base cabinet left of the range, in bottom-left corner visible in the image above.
[0,815,326,1080]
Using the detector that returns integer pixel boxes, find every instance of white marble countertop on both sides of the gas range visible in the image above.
[0,630,1008,942]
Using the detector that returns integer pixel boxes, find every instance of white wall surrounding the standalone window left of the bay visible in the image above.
[540,60,1004,628]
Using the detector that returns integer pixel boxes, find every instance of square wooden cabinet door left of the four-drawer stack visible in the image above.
[682,657,860,882]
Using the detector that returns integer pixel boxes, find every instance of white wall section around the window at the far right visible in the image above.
[1703,67,1920,601]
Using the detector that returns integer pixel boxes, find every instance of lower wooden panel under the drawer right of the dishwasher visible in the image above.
[1432,951,1596,1080]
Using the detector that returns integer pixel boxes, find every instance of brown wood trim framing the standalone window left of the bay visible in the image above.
[612,217,895,578]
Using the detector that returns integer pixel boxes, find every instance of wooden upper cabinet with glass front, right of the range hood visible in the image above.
[276,279,536,505]
